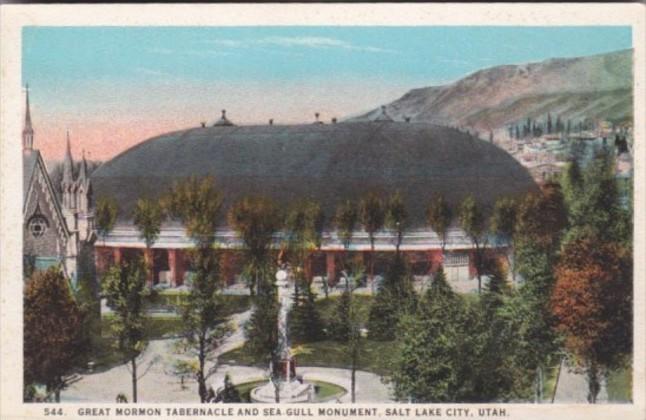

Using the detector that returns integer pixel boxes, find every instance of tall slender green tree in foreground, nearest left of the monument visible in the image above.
[182,248,229,403]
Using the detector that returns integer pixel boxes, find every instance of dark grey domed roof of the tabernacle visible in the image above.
[92,122,537,227]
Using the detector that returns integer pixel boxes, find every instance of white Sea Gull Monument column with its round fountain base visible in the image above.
[250,269,314,403]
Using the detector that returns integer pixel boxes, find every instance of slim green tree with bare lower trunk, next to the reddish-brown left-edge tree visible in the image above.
[103,259,150,402]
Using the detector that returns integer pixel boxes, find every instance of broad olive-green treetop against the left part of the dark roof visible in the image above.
[163,176,222,248]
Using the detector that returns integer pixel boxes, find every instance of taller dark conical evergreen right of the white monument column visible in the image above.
[368,254,417,341]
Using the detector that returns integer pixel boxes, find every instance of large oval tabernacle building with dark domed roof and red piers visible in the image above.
[91,108,537,291]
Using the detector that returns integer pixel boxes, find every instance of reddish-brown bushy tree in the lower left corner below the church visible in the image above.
[23,267,83,402]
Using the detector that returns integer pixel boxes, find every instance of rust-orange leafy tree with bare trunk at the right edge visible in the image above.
[551,235,632,403]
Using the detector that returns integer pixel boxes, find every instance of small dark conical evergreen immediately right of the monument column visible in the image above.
[289,282,324,343]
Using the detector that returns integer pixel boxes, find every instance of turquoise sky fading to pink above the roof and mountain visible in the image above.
[21,26,632,161]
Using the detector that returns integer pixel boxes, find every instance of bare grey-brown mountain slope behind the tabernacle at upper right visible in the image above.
[352,50,633,131]
